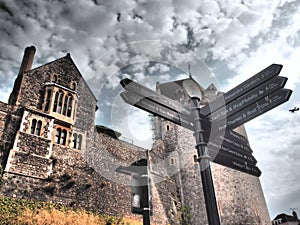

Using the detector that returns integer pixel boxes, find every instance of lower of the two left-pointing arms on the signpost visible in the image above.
[121,92,194,130]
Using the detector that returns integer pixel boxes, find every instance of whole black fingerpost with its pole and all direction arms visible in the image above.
[120,64,292,225]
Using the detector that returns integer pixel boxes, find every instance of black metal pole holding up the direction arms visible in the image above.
[192,97,221,225]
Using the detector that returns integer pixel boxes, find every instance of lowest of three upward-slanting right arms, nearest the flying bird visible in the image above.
[218,89,292,130]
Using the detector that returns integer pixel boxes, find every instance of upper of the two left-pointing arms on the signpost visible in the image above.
[120,78,190,116]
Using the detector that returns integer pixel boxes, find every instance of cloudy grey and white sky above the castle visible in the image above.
[0,0,300,218]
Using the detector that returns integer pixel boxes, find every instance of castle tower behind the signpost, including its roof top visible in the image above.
[153,76,271,225]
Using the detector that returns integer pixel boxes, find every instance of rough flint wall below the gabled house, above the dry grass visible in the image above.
[1,133,170,224]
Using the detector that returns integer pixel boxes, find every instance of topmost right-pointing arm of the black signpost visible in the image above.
[201,64,282,116]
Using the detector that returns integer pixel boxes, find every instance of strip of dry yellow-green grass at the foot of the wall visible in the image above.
[0,197,141,225]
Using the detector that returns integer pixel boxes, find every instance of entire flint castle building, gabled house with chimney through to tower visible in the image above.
[0,46,271,225]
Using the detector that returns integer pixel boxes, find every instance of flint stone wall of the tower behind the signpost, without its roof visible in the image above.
[154,122,270,225]
